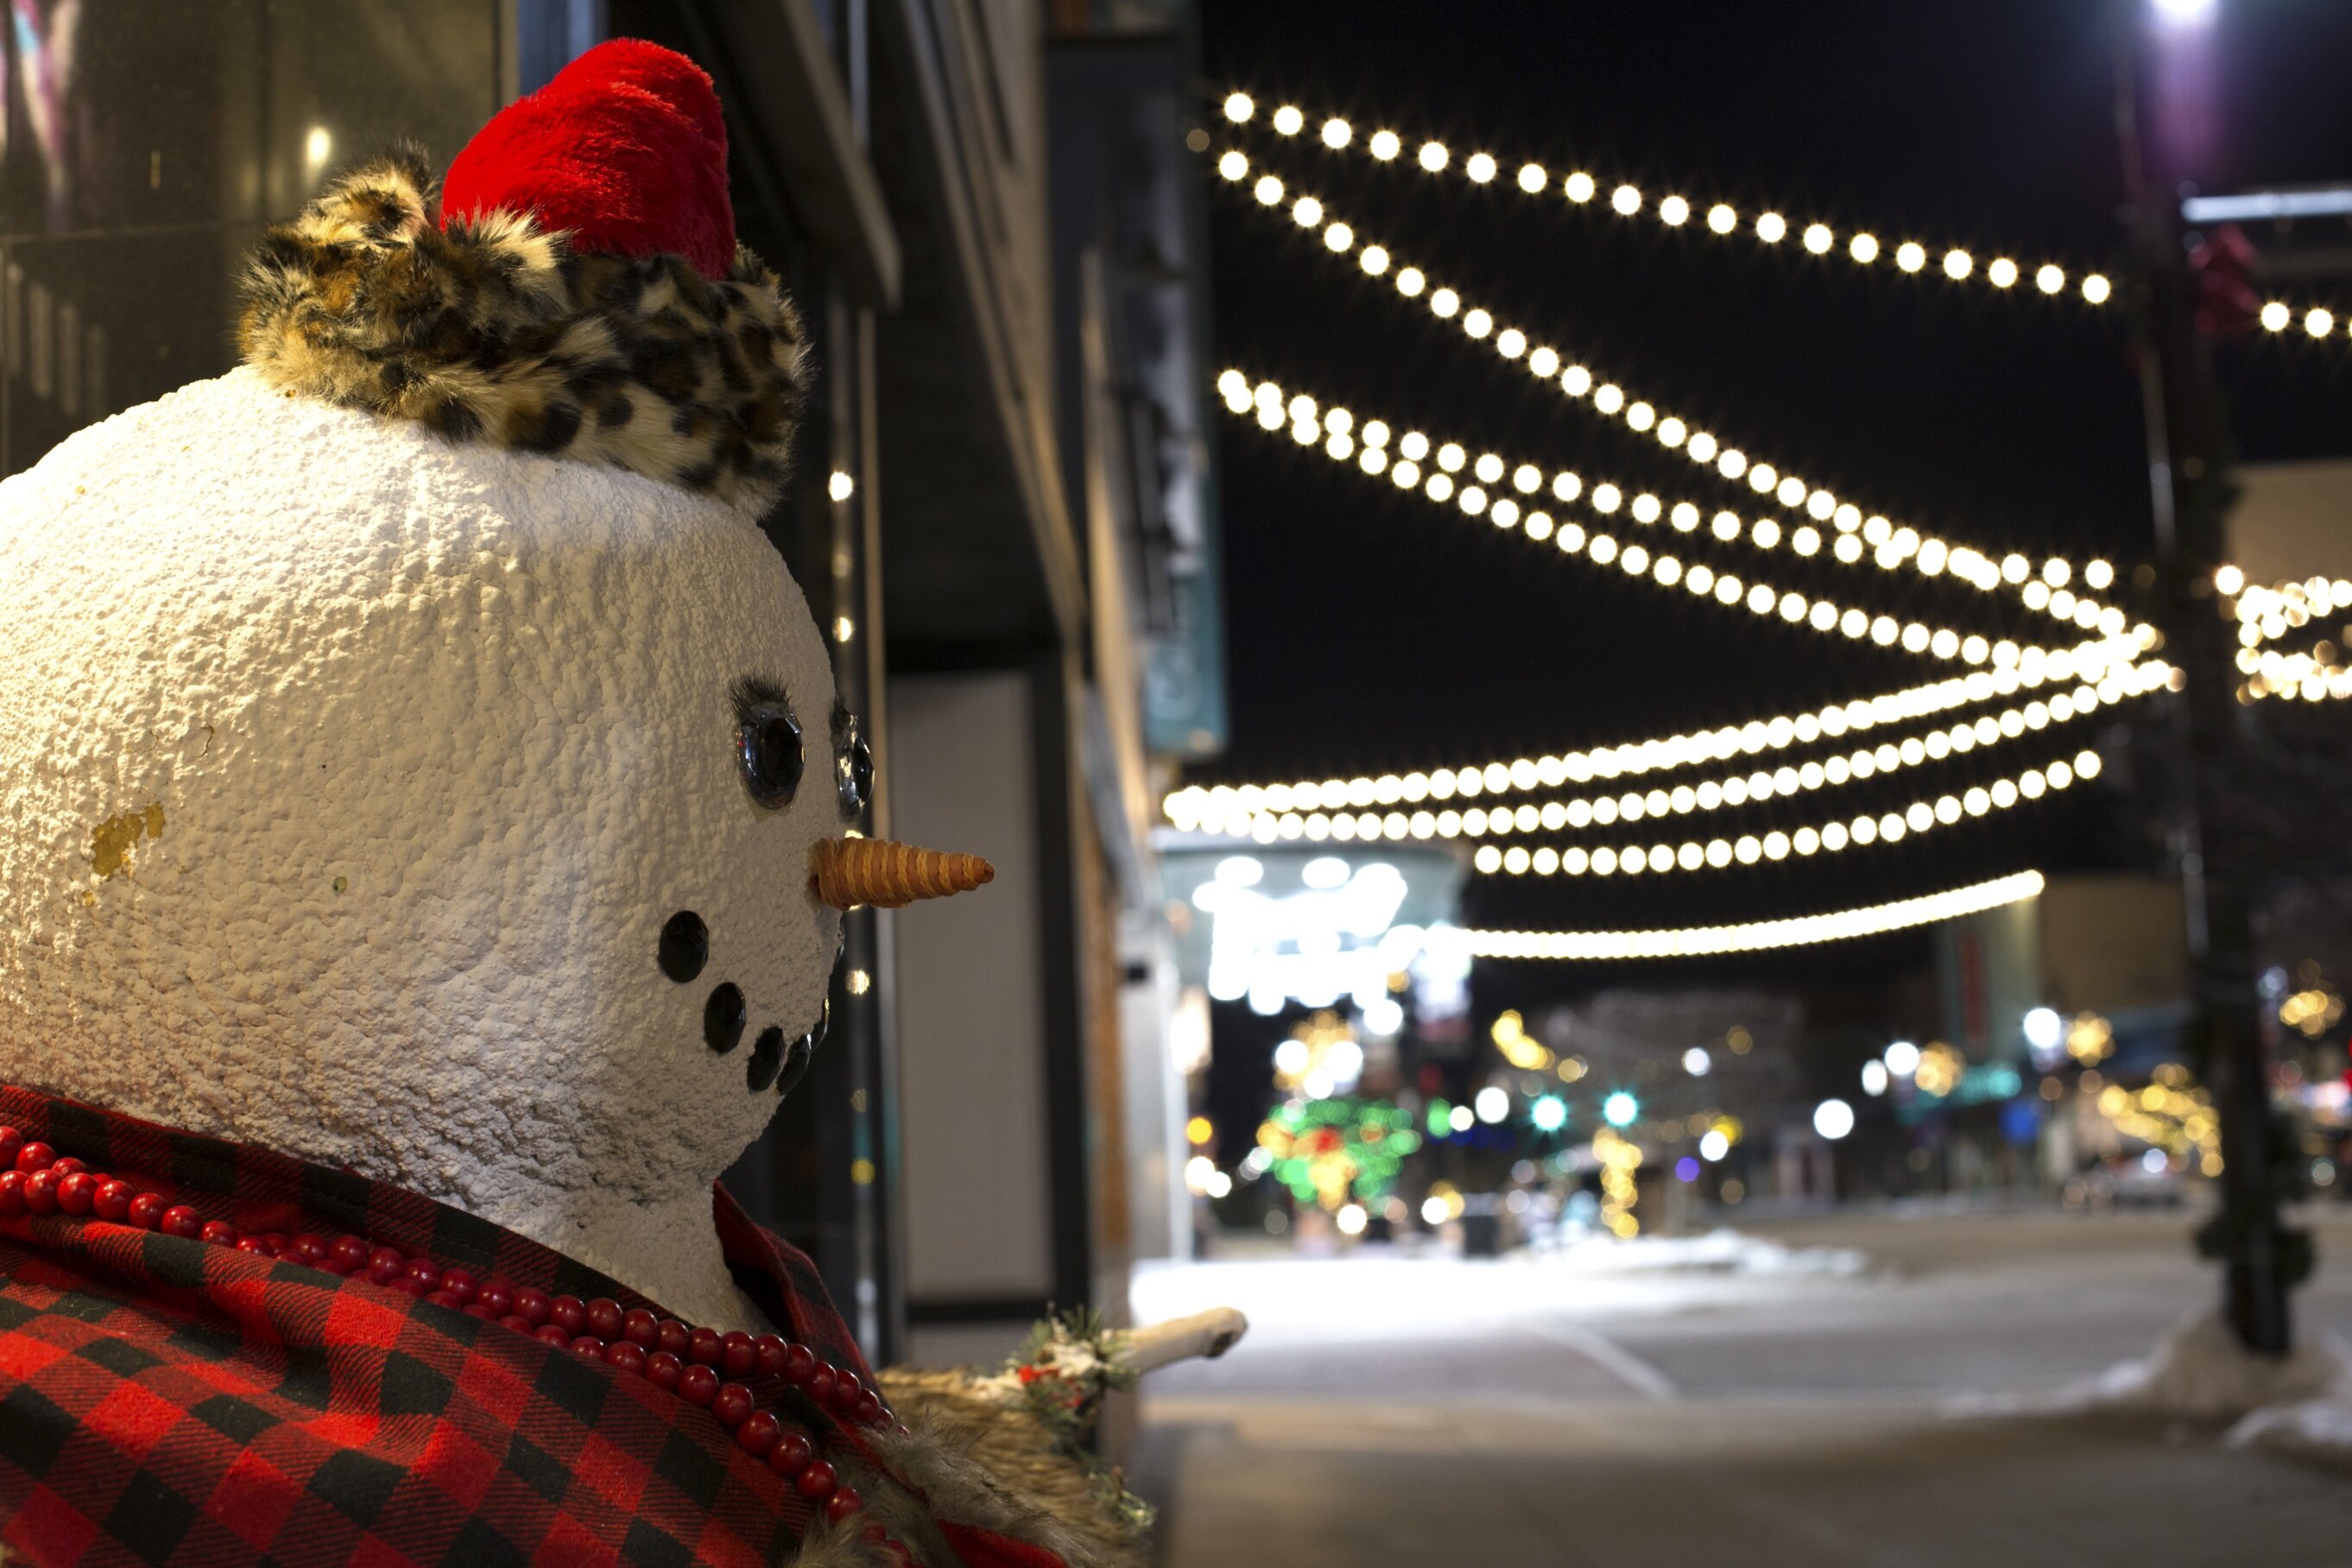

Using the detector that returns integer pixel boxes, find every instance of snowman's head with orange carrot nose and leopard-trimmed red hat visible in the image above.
[0,45,988,1234]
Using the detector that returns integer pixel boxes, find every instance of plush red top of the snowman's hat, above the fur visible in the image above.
[442,38,737,277]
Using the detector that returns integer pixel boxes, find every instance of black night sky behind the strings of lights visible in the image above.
[1192,0,2352,1011]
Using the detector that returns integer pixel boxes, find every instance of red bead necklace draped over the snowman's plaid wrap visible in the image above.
[0,1126,913,1561]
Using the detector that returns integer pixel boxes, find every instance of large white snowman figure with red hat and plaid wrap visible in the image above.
[0,40,1240,1568]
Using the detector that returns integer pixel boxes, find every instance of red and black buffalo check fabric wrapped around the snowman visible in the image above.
[0,1089,870,1568]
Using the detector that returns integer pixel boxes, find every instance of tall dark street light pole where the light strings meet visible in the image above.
[2115,0,2307,1356]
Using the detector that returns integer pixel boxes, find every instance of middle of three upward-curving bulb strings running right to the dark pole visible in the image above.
[1164,661,2171,844]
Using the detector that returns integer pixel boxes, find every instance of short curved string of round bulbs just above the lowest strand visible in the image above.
[1457,750,2101,877]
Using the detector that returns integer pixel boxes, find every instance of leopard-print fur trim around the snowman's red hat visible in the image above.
[237,153,809,510]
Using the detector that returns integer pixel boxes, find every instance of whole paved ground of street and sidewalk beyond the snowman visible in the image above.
[1136,1211,2352,1568]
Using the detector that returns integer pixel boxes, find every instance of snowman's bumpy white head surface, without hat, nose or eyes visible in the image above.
[0,369,844,1239]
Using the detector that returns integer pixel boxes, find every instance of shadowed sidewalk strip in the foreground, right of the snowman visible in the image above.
[1138,1399,2352,1568]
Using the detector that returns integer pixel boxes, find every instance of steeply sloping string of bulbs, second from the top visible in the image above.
[1218,150,2112,616]
